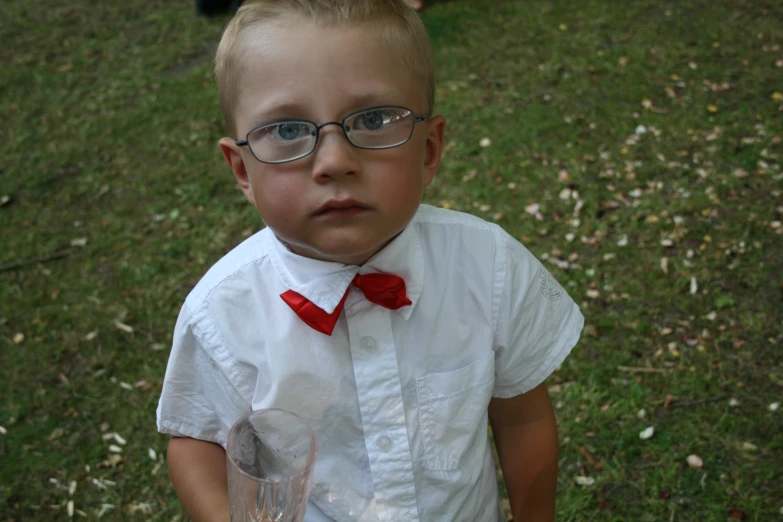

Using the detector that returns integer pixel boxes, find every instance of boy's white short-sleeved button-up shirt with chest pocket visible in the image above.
[158,205,583,522]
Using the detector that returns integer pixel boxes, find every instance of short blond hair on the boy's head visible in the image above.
[215,0,435,135]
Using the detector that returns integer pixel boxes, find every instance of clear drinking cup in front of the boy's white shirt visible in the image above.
[226,409,318,522]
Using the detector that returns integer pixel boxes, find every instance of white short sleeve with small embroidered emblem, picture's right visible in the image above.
[492,232,584,398]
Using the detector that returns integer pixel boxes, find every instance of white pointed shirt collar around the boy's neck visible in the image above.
[270,214,424,319]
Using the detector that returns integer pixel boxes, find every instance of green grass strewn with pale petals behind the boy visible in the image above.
[0,0,783,522]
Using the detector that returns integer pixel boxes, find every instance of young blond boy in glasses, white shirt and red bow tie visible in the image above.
[158,0,583,522]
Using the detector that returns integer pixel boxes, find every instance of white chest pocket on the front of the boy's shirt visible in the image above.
[416,354,495,471]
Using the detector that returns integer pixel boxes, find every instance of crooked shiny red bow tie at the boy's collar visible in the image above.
[280,274,411,335]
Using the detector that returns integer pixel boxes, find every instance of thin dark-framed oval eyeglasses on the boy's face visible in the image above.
[236,107,427,163]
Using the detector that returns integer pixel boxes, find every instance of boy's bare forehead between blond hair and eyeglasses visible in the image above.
[236,20,423,133]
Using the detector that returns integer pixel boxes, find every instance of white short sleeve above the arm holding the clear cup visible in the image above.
[157,304,250,447]
